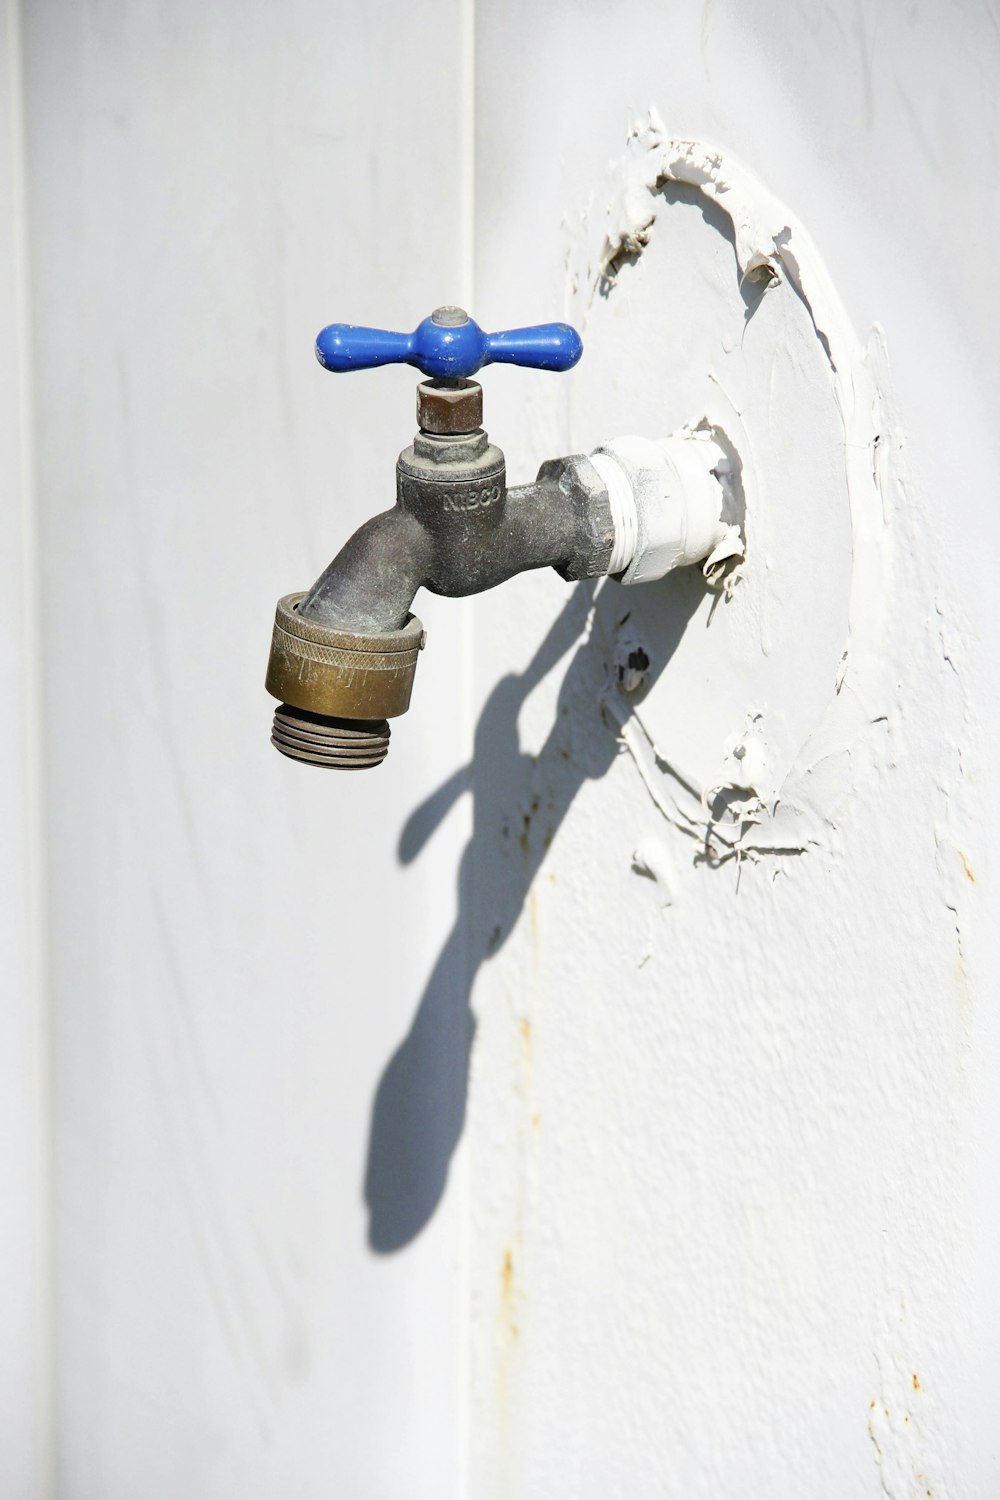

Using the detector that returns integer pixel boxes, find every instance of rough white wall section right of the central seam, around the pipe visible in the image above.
[469,0,1000,1500]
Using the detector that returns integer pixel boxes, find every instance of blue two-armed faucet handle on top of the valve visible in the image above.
[316,308,583,380]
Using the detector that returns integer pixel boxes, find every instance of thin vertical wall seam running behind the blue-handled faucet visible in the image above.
[456,0,477,1500]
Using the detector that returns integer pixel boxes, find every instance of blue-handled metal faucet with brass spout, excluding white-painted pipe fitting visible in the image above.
[265,308,593,767]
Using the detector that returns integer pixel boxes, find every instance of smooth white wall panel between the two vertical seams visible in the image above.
[10,3,466,1500]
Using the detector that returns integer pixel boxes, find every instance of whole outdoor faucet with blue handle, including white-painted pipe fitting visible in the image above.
[265,308,742,770]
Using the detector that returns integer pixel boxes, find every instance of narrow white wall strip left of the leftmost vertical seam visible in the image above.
[0,8,51,1496]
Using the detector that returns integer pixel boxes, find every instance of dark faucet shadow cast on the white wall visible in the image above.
[364,569,705,1254]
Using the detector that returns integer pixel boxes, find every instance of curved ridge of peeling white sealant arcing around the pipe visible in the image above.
[570,110,900,858]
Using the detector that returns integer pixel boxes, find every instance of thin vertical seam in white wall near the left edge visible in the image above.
[7,0,55,1500]
